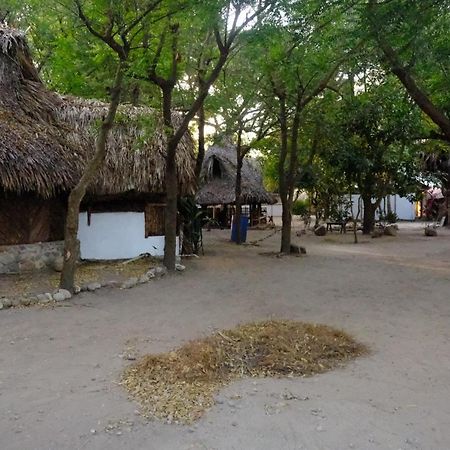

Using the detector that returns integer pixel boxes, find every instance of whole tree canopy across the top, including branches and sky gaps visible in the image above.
[0,0,450,265]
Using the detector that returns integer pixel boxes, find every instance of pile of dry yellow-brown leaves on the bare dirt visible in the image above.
[122,321,366,423]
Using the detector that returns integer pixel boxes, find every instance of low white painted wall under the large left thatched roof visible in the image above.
[78,212,178,259]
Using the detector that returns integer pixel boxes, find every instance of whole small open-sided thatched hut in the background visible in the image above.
[196,144,275,227]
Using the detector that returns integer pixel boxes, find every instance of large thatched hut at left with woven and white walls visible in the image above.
[0,26,195,259]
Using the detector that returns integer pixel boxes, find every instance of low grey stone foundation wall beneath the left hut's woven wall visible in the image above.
[0,241,64,273]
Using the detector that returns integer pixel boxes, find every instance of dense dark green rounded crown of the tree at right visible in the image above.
[326,77,428,203]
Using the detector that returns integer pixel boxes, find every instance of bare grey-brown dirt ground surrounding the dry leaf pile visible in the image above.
[0,225,450,450]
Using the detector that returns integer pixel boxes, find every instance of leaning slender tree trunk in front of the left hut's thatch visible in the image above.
[60,60,125,292]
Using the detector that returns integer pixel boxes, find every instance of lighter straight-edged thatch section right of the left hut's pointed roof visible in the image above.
[57,97,195,194]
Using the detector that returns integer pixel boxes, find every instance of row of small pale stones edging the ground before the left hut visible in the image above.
[0,264,186,310]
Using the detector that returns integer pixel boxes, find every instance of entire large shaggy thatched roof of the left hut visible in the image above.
[0,26,195,198]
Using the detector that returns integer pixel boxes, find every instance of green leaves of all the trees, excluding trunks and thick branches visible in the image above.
[0,0,450,221]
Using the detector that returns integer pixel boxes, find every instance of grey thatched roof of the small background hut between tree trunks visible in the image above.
[196,144,275,206]
